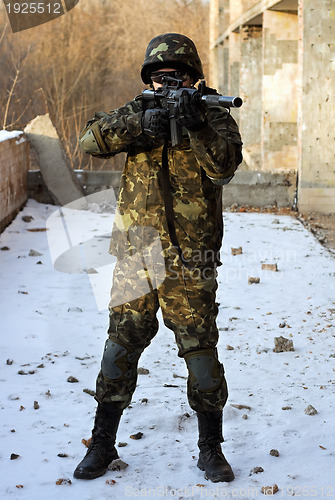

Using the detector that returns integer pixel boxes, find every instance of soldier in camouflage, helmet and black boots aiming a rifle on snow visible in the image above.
[74,33,242,482]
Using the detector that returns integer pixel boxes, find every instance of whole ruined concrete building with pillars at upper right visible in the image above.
[210,0,335,213]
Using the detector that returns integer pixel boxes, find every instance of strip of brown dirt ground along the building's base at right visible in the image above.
[224,205,335,255]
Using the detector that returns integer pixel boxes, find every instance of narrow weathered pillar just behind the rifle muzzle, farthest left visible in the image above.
[239,26,263,170]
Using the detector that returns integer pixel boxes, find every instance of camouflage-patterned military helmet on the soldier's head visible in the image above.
[141,33,204,83]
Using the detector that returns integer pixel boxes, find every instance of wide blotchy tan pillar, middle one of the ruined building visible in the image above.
[262,10,298,171]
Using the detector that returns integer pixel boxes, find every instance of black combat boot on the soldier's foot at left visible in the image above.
[73,403,122,479]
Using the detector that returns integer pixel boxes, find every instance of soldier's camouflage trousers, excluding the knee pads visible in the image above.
[96,254,228,411]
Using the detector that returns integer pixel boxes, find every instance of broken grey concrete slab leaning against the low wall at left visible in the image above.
[24,114,83,205]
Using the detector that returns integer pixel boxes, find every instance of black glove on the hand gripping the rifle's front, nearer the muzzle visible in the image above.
[176,89,207,131]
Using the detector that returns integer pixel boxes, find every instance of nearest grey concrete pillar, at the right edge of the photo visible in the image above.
[298,0,335,213]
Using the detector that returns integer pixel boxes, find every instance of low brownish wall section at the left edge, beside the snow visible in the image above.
[0,133,29,232]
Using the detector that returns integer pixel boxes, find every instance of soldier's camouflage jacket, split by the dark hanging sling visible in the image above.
[80,96,242,265]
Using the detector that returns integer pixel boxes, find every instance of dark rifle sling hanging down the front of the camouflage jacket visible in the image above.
[162,143,193,269]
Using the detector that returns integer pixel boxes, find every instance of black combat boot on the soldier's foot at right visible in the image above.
[197,410,235,483]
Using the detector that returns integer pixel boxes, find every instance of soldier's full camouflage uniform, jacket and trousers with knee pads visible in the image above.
[81,37,242,412]
